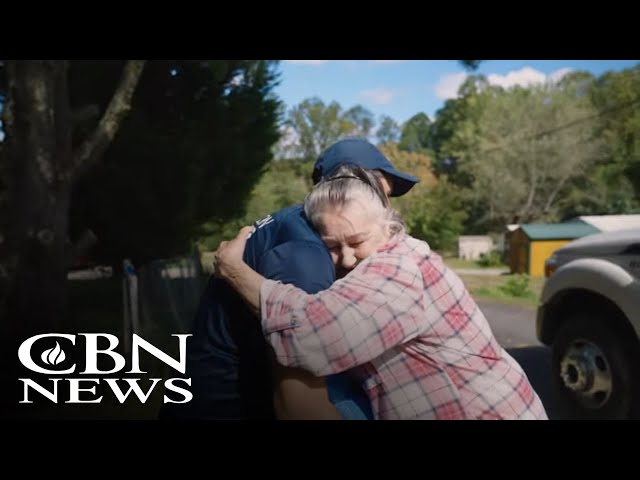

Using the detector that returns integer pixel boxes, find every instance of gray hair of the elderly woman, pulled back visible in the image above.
[304,165,404,235]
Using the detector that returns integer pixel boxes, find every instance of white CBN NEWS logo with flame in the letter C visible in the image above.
[18,333,193,403]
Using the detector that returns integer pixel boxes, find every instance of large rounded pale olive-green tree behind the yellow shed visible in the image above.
[444,84,605,227]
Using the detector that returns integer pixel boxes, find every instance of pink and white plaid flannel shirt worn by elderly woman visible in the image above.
[260,235,547,419]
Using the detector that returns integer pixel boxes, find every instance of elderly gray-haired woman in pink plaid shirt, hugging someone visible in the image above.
[216,167,547,419]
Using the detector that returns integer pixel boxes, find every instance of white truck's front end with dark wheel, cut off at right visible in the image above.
[536,229,640,419]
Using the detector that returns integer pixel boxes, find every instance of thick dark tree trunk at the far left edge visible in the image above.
[2,61,72,341]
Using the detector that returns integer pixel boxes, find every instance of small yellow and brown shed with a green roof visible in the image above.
[509,222,600,277]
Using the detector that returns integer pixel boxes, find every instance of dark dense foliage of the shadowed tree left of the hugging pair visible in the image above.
[71,60,279,264]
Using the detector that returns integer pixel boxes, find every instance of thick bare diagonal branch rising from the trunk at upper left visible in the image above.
[69,60,145,177]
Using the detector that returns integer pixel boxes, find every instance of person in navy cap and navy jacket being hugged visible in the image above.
[160,138,418,420]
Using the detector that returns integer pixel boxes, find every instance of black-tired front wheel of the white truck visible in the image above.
[552,312,640,420]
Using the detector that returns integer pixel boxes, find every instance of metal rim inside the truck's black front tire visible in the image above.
[560,340,613,410]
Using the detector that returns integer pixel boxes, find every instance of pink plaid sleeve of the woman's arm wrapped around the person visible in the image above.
[260,253,424,375]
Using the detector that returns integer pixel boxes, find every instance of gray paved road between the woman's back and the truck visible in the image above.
[478,300,562,419]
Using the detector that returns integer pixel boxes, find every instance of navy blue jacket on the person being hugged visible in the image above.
[161,205,370,419]
